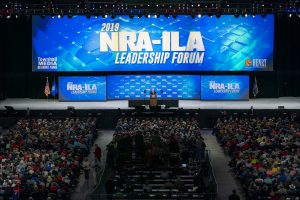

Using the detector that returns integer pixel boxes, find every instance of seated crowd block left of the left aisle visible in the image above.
[0,118,97,200]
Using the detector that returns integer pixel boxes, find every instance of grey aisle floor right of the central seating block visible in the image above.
[201,129,245,200]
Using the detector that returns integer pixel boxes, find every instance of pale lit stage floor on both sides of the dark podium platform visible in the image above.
[0,97,300,110]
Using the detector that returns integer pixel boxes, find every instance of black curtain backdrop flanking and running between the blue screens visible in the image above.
[0,17,300,98]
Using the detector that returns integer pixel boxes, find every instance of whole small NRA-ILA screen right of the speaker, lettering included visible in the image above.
[201,76,249,100]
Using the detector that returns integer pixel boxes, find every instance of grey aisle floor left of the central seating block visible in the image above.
[71,130,114,200]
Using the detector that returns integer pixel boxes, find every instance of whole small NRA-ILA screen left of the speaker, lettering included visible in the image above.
[58,76,106,101]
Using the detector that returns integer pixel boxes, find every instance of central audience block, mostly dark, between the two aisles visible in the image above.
[106,118,213,199]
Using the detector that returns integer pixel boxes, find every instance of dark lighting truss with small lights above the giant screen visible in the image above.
[0,0,300,19]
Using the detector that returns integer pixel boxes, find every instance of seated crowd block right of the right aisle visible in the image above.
[214,116,300,200]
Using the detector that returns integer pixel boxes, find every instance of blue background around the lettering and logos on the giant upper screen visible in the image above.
[32,15,274,72]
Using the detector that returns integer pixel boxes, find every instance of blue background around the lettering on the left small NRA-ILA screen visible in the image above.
[58,76,106,101]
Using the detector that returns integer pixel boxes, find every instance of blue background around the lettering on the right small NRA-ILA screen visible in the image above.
[201,76,249,100]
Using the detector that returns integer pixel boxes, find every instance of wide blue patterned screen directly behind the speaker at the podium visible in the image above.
[107,75,200,99]
